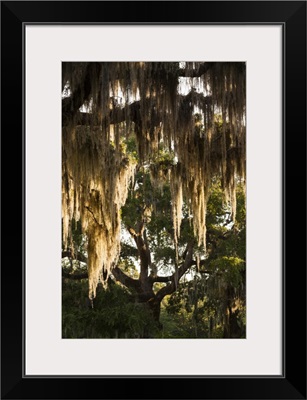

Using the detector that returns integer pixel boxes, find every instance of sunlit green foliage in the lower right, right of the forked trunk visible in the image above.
[162,182,246,338]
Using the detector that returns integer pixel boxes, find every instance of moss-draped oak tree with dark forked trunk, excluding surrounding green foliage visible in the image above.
[62,62,246,338]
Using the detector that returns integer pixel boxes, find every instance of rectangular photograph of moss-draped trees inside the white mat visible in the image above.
[62,61,246,339]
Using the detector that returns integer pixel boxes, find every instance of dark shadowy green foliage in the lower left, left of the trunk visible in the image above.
[62,279,156,339]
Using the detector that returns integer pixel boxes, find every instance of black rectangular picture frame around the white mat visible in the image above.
[1,1,306,399]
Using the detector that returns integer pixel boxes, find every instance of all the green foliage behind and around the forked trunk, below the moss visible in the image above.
[63,176,246,338]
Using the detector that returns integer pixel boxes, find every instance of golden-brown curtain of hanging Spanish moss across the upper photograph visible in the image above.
[62,62,246,296]
